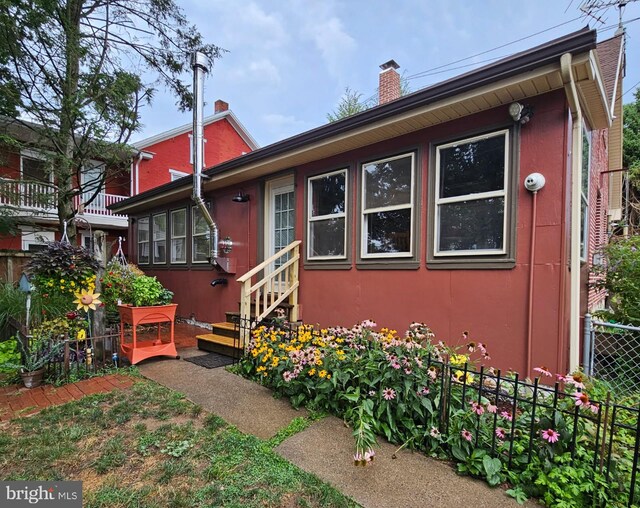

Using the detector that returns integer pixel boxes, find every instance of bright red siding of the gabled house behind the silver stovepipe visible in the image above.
[138,118,251,192]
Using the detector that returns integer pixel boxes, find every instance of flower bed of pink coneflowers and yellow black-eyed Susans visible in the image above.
[239,321,639,508]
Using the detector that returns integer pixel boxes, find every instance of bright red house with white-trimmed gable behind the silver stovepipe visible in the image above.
[131,100,258,196]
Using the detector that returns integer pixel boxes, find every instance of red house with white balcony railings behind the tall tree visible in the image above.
[0,120,129,251]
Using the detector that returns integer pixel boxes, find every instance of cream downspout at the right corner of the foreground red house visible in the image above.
[560,53,582,372]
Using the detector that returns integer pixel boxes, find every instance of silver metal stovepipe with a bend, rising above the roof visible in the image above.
[191,51,220,265]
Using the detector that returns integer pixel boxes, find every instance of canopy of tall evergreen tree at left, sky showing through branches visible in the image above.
[0,0,223,236]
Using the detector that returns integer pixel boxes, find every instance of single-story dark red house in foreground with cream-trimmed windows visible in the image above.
[113,28,624,373]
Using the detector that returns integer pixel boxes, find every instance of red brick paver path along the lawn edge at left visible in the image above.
[0,374,134,422]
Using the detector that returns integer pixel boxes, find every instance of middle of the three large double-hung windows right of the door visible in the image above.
[360,153,416,259]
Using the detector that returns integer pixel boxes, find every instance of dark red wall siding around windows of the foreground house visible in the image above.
[131,91,570,371]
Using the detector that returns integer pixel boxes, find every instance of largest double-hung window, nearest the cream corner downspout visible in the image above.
[432,129,511,259]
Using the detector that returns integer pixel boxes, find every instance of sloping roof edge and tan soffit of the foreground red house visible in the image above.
[114,27,610,213]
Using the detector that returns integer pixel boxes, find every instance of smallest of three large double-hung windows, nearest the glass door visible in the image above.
[307,169,347,260]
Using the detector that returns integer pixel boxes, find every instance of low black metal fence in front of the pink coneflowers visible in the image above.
[238,320,640,507]
